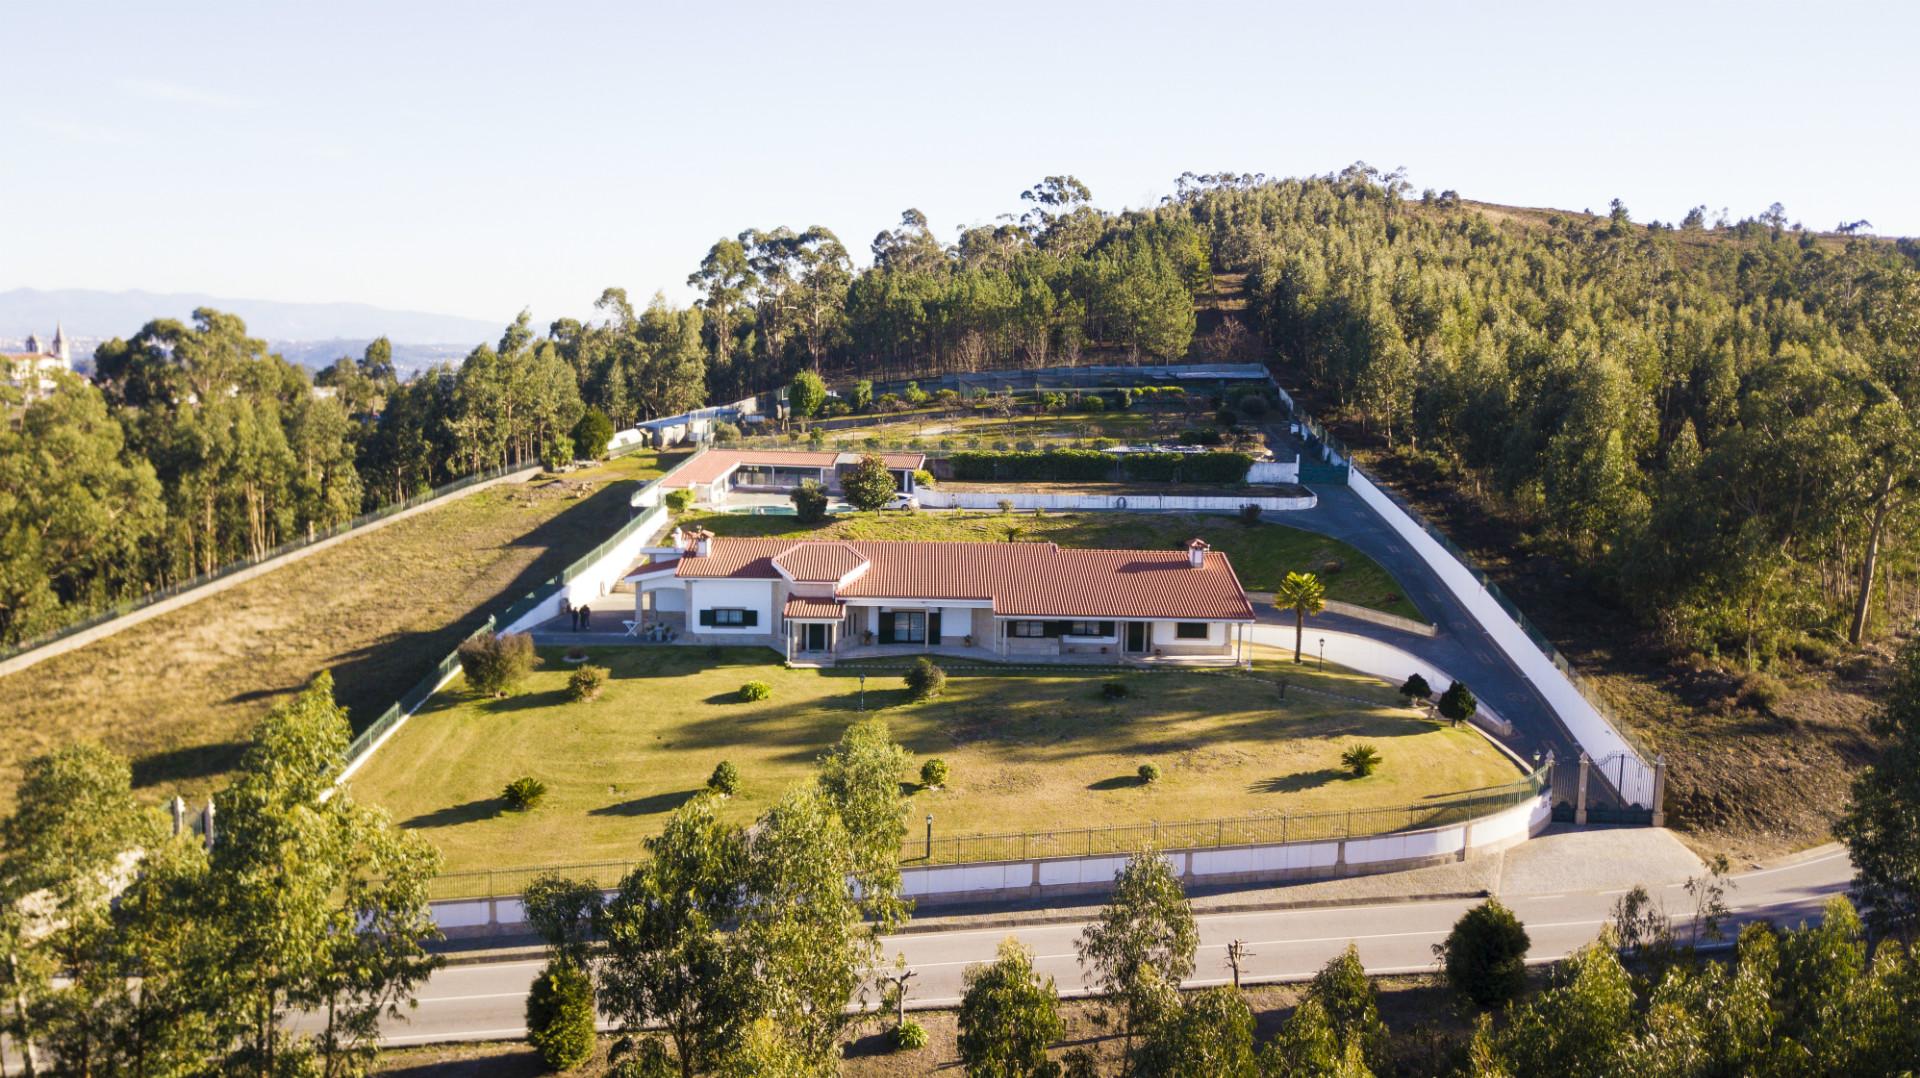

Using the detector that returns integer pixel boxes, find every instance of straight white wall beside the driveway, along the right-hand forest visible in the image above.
[1329,469,1653,805]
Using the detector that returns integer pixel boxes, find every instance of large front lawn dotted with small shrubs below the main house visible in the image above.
[353,648,1519,872]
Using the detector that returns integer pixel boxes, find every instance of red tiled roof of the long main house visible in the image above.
[676,538,1254,621]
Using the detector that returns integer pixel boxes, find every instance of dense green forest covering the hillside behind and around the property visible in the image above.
[0,165,1920,665]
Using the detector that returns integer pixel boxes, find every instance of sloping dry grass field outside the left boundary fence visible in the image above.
[0,452,678,803]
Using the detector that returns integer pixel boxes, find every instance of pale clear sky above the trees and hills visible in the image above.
[0,0,1920,323]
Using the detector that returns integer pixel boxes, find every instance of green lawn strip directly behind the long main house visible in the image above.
[687,509,1427,621]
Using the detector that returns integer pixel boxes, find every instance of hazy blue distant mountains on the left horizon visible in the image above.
[0,288,511,371]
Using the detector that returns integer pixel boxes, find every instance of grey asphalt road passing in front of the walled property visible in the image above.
[366,847,1853,1045]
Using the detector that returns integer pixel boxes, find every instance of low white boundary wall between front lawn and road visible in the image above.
[432,780,1553,938]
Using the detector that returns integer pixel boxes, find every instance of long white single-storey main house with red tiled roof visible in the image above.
[628,530,1254,665]
